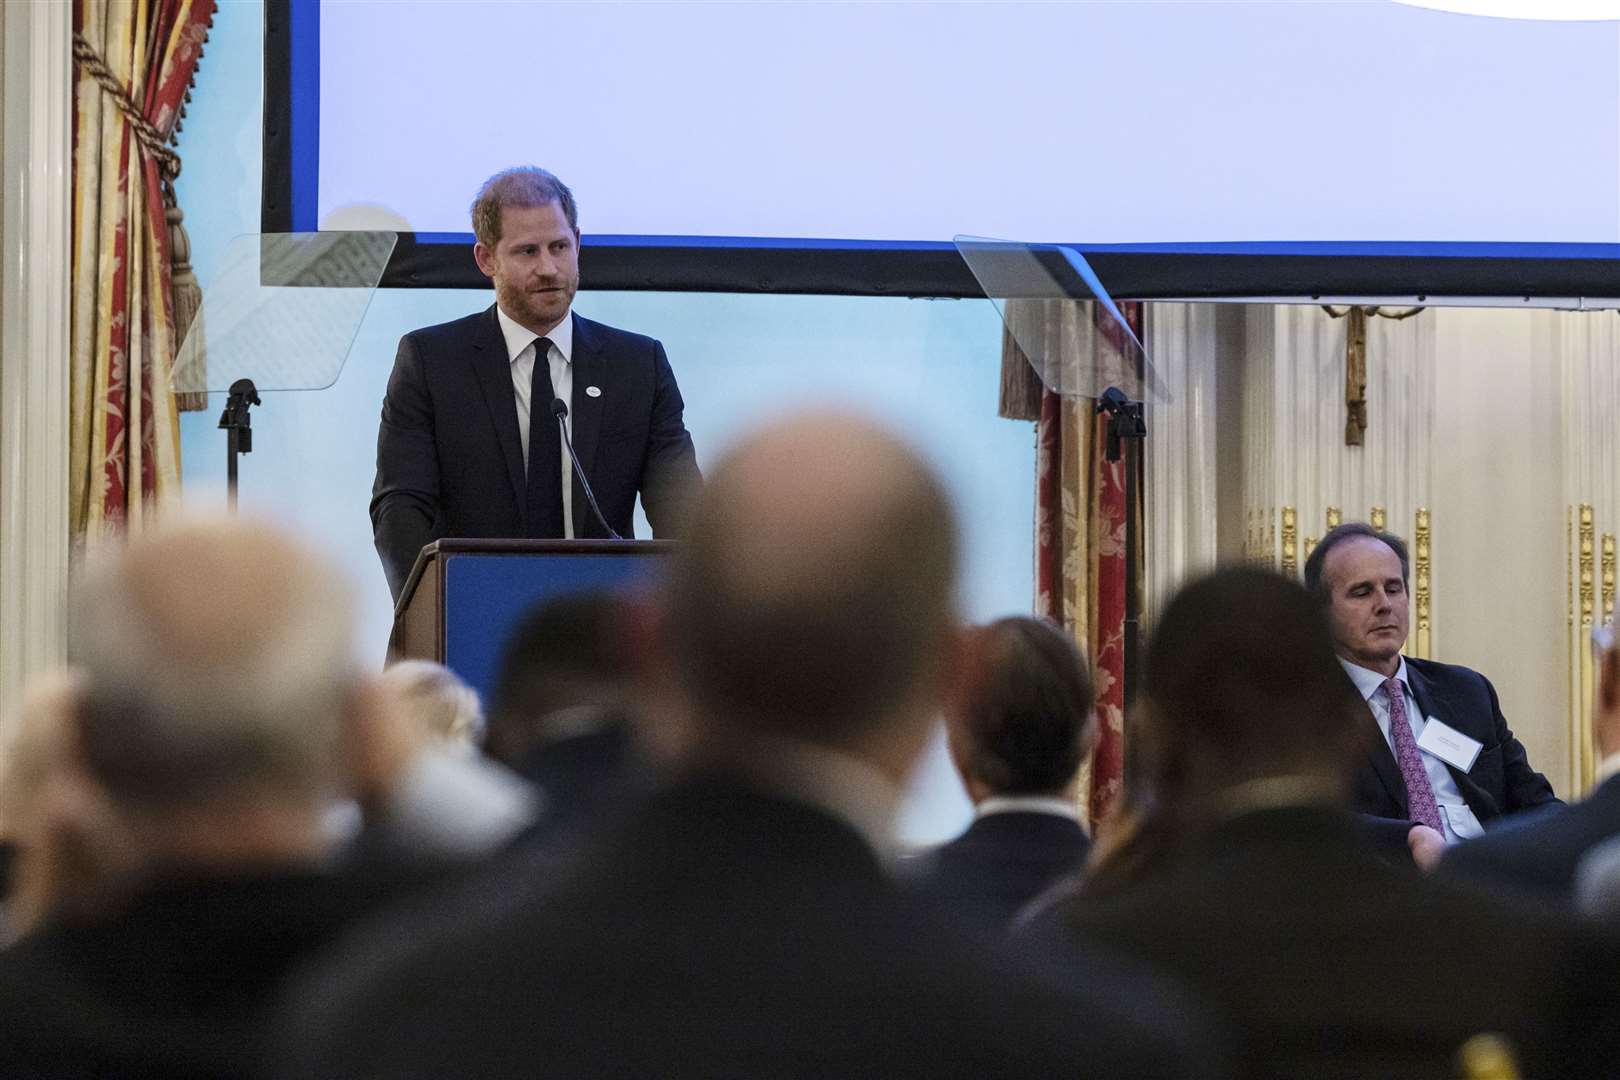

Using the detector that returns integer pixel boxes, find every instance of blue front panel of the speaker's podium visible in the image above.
[444,552,667,709]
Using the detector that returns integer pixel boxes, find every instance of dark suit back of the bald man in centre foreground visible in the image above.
[285,784,1218,1078]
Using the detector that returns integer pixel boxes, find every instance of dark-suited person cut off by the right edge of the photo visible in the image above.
[1440,599,1620,902]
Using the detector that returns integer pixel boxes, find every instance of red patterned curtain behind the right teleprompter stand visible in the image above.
[1001,303,1142,827]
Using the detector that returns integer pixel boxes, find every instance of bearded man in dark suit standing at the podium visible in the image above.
[371,167,701,599]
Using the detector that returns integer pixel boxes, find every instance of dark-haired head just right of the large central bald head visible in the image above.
[954,617,1097,795]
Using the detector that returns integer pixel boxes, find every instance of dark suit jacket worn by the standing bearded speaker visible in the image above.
[371,304,700,599]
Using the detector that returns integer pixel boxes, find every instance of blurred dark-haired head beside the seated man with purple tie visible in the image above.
[1142,568,1361,801]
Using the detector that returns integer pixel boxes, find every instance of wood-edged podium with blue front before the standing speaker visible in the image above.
[389,539,676,708]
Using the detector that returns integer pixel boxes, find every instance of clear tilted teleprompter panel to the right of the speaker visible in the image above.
[956,236,1170,403]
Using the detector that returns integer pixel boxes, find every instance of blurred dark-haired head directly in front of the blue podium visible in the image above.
[484,589,635,764]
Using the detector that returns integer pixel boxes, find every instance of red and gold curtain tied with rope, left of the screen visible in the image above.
[70,0,215,542]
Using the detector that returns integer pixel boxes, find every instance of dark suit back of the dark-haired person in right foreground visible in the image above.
[1040,810,1592,1078]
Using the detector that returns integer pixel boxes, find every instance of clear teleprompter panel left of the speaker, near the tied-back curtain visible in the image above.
[172,232,399,393]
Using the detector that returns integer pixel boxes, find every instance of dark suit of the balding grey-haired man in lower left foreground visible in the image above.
[0,863,449,1080]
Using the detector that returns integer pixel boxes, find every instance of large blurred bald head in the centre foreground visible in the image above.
[669,413,957,745]
